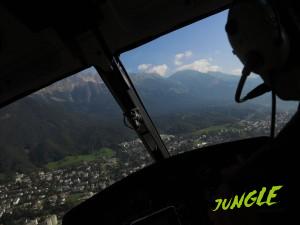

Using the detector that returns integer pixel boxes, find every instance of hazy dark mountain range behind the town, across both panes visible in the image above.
[0,70,292,172]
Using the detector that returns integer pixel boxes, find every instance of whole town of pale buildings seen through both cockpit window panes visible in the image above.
[0,113,289,225]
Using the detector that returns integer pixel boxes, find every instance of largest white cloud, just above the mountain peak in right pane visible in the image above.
[176,59,221,73]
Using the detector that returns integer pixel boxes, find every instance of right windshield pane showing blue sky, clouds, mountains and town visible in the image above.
[121,11,297,154]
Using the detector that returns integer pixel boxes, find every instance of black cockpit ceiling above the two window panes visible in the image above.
[0,0,231,106]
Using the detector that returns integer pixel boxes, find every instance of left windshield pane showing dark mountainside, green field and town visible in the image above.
[0,68,152,225]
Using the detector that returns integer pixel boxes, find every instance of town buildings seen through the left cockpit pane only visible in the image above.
[0,152,149,225]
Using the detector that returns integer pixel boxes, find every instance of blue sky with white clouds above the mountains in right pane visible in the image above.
[121,11,242,76]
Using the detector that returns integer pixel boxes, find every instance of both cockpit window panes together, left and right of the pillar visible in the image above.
[0,8,296,225]
